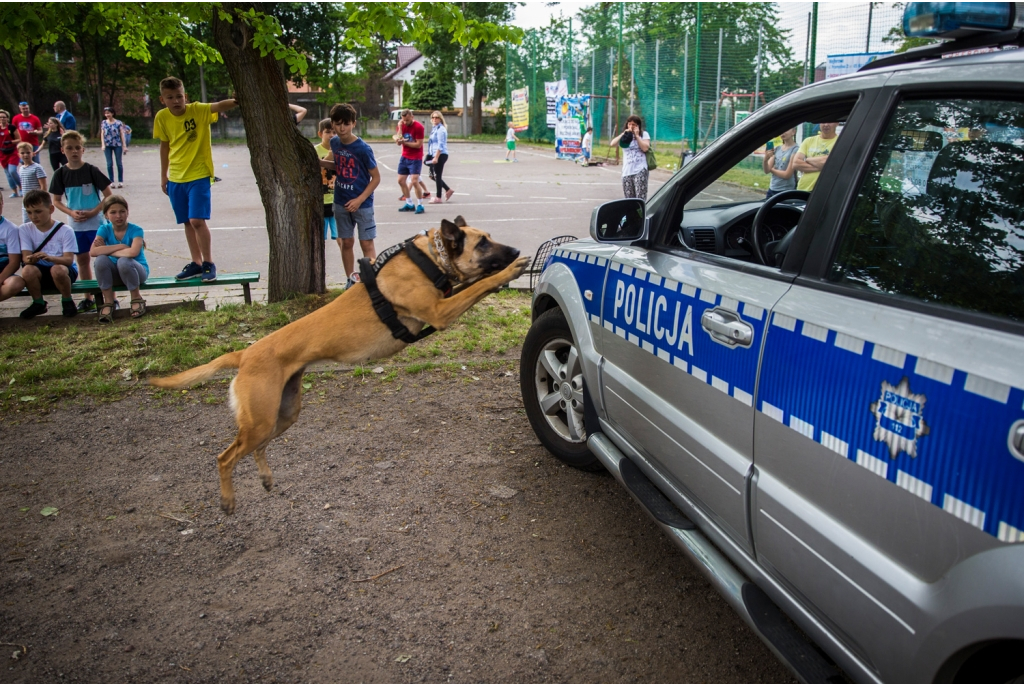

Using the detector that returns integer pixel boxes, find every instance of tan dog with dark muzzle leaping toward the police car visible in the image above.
[150,216,529,514]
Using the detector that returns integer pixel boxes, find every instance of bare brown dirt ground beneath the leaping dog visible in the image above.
[0,360,792,683]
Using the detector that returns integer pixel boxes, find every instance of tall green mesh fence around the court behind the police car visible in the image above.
[506,2,903,163]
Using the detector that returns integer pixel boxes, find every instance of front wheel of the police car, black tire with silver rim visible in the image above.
[519,307,603,471]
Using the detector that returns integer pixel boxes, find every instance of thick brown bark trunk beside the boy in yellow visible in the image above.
[212,3,326,302]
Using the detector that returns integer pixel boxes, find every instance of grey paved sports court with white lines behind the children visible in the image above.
[0,143,753,316]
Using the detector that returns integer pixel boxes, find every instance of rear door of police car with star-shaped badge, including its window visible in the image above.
[752,87,1024,680]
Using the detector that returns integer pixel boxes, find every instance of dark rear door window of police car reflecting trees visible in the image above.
[828,99,1024,322]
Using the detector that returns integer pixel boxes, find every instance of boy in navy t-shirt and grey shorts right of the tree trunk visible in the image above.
[321,103,381,288]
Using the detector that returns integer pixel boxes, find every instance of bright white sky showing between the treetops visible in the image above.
[515,1,902,63]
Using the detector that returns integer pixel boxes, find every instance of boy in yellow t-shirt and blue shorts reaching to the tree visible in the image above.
[153,76,238,282]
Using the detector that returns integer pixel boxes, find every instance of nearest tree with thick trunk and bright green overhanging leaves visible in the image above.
[0,2,521,301]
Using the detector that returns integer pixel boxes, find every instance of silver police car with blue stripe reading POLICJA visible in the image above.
[521,3,1024,682]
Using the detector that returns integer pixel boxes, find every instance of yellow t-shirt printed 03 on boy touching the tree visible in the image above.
[153,102,216,183]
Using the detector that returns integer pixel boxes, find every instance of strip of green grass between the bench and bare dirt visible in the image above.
[0,290,530,413]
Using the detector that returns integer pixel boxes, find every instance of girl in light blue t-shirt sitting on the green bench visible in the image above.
[89,195,150,324]
